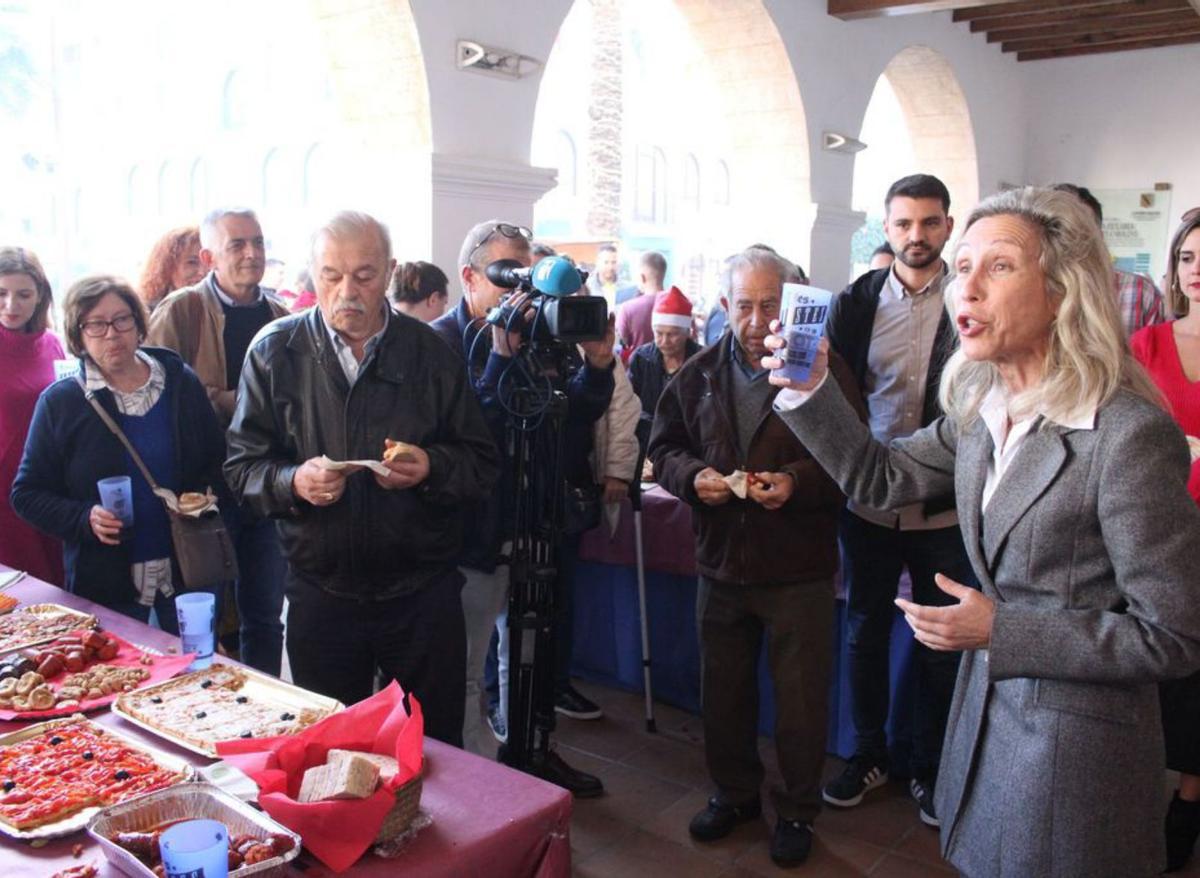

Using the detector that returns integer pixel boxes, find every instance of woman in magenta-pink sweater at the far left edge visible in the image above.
[0,247,64,585]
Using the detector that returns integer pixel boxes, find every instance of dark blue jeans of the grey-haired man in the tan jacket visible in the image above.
[230,506,288,676]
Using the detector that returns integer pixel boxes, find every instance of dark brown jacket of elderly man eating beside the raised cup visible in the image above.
[649,343,857,585]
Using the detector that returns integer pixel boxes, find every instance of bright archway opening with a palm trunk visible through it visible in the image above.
[532,0,811,299]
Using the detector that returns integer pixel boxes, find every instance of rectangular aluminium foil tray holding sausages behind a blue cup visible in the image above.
[88,783,300,878]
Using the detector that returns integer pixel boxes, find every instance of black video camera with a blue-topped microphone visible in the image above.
[486,255,608,344]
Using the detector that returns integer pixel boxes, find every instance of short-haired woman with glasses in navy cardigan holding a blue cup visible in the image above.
[12,276,226,633]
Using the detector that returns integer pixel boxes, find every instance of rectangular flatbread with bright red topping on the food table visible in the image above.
[0,717,187,830]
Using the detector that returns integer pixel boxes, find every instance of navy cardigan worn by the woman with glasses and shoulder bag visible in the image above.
[12,348,226,606]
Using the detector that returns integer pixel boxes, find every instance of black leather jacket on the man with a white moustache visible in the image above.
[226,308,499,600]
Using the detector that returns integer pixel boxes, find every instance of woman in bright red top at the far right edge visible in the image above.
[1129,208,1200,872]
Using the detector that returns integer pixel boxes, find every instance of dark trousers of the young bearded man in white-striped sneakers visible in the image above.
[841,510,978,784]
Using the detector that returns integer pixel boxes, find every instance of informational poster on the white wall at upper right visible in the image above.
[1092,188,1171,284]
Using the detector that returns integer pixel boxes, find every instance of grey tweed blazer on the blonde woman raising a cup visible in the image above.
[784,381,1200,878]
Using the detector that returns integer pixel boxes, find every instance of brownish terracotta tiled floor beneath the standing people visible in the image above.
[470,681,1200,878]
